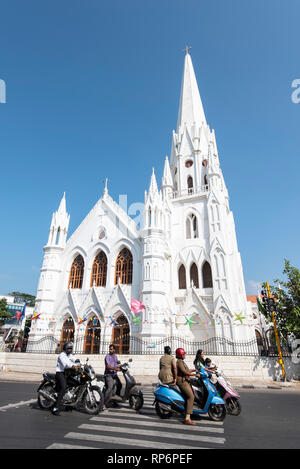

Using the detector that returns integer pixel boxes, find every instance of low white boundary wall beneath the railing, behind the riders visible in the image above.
[0,352,300,380]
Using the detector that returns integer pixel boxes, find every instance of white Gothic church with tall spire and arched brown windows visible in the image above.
[28,51,255,353]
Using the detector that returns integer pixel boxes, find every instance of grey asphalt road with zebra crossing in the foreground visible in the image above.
[0,382,300,450]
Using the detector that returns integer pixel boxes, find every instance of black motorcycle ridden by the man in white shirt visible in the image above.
[37,358,103,415]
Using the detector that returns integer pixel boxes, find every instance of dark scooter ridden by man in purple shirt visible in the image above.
[96,358,144,410]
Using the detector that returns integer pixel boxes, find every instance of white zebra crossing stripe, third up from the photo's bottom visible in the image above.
[78,423,225,445]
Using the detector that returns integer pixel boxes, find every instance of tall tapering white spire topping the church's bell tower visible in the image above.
[177,48,206,134]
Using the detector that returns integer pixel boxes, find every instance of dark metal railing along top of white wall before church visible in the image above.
[20,335,291,357]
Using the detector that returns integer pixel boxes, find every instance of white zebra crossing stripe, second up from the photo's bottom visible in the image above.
[65,432,208,449]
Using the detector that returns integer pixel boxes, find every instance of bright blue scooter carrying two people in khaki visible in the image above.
[153,370,226,422]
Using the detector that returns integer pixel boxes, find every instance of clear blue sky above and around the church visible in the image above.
[0,0,300,294]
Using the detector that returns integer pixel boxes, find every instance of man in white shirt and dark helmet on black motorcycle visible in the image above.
[51,342,78,415]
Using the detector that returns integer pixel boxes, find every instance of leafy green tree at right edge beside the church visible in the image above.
[263,259,300,342]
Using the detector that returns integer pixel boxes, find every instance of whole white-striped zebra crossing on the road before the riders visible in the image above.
[48,388,225,449]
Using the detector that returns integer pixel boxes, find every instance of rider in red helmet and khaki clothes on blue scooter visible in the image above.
[176,348,199,425]
